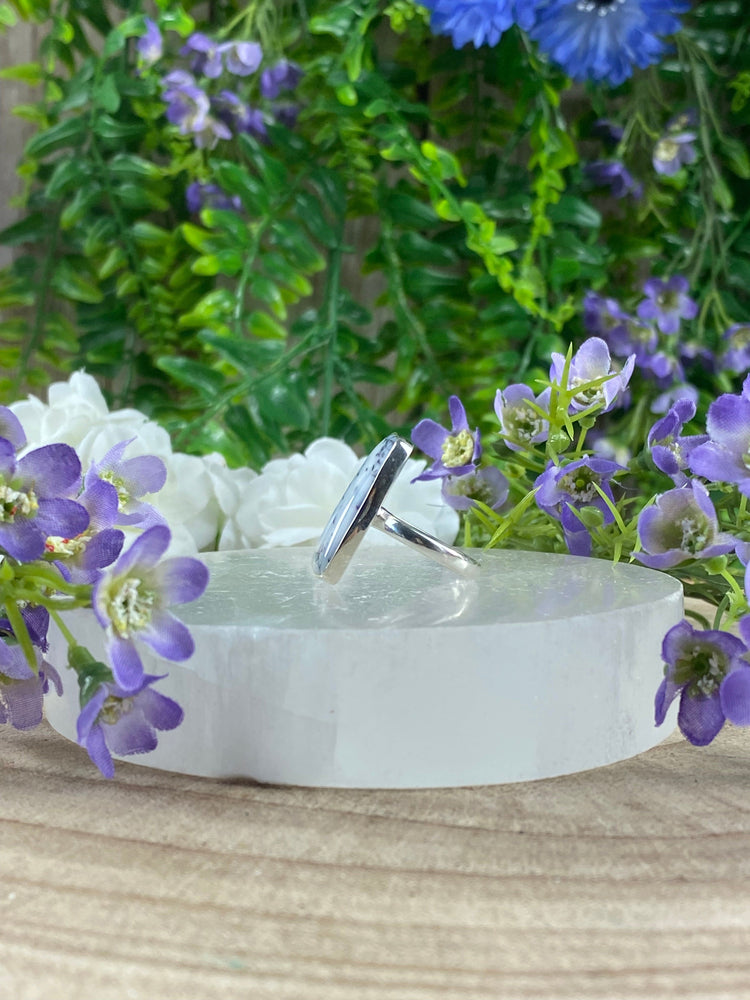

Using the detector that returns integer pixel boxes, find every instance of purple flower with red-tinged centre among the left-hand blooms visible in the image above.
[45,479,125,583]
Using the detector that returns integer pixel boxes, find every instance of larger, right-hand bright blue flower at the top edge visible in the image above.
[530,0,690,87]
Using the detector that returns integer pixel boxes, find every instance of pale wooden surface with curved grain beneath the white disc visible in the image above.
[0,726,750,1000]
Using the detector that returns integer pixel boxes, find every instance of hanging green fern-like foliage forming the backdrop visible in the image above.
[0,0,750,465]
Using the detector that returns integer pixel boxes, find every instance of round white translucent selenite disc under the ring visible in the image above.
[46,545,682,788]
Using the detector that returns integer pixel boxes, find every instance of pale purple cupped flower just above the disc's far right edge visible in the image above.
[635,479,737,569]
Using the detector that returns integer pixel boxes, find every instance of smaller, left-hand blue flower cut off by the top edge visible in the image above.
[422,0,535,49]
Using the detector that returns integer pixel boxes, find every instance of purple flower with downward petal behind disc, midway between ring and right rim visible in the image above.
[534,456,623,556]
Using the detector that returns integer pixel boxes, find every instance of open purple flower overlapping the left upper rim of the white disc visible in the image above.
[92,524,208,691]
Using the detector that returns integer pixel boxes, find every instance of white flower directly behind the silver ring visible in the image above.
[226,438,458,548]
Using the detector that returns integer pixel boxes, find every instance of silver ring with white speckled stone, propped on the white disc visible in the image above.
[313,434,479,583]
